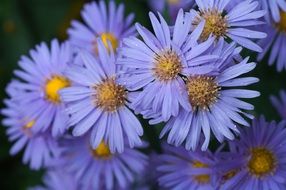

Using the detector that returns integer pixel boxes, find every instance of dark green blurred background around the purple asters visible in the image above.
[0,0,286,190]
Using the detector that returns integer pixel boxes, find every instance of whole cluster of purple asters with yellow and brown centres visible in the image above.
[1,0,286,190]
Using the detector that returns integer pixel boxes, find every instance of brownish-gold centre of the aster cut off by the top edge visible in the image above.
[193,10,228,40]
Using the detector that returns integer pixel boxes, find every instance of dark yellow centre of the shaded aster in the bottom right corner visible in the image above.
[248,147,276,177]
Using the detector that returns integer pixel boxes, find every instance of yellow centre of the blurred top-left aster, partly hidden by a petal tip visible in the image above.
[93,33,118,54]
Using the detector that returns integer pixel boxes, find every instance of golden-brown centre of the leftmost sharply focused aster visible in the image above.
[94,78,127,112]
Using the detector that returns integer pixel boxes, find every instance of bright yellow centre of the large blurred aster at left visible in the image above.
[45,75,70,104]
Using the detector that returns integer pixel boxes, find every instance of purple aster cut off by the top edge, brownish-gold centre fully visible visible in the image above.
[190,0,266,52]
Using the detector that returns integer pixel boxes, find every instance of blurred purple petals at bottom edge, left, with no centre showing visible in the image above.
[29,169,80,190]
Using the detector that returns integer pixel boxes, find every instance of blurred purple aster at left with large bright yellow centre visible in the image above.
[9,40,73,136]
